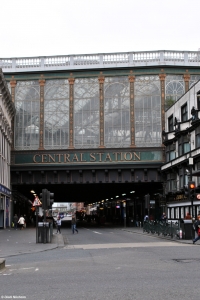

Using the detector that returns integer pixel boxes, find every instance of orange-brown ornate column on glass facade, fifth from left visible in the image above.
[128,72,135,148]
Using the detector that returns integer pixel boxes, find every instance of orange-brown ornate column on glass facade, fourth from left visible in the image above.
[98,75,105,148]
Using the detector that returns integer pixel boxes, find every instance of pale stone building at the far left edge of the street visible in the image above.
[0,69,15,228]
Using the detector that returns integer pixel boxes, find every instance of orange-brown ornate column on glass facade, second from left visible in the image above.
[39,75,45,150]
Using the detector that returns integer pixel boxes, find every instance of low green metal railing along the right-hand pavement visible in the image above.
[143,221,181,239]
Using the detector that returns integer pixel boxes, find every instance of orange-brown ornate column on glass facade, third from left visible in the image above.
[68,77,75,149]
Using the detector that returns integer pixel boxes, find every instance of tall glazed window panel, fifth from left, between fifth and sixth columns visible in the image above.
[134,76,162,147]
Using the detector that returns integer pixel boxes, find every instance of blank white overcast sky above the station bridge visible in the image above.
[0,0,200,58]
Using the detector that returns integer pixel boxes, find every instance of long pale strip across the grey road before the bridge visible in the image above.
[64,242,193,250]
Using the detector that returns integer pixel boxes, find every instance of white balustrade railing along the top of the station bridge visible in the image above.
[0,50,200,73]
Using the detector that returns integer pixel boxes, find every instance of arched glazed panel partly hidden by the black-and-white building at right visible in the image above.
[165,75,185,102]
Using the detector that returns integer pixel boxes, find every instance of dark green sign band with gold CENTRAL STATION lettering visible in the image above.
[12,151,162,165]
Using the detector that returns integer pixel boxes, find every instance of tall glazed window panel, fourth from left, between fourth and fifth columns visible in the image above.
[104,77,130,148]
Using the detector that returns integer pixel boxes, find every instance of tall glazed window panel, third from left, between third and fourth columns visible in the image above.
[74,78,99,149]
